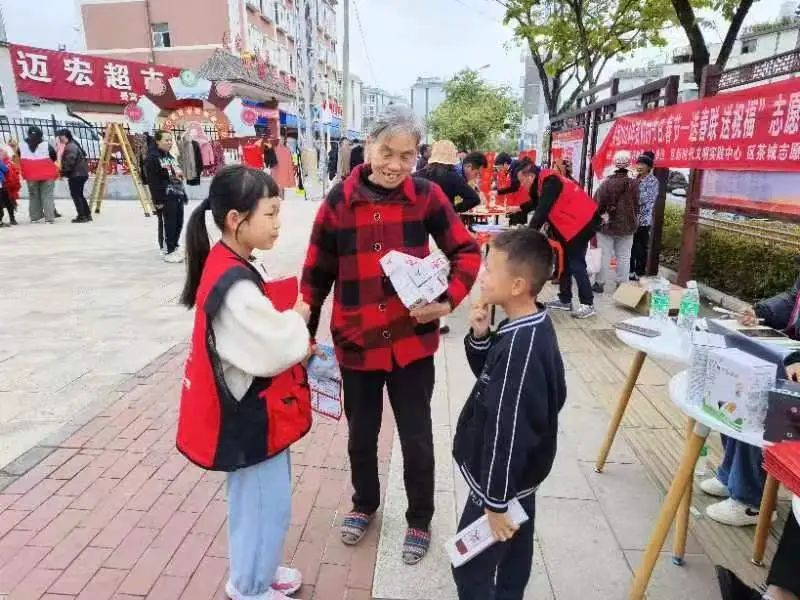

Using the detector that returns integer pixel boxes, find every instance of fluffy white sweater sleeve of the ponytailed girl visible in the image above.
[212,280,309,400]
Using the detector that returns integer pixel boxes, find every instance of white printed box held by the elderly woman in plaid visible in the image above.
[380,250,450,310]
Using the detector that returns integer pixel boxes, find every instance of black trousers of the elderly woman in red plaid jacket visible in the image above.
[342,357,435,531]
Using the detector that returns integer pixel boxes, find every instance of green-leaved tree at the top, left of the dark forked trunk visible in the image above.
[505,0,674,117]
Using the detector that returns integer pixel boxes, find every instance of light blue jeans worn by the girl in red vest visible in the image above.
[228,450,292,599]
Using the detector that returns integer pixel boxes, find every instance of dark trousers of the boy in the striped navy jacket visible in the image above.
[453,494,536,600]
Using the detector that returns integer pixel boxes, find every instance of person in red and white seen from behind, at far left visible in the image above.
[19,125,59,223]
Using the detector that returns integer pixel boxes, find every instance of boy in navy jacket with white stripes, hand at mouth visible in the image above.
[453,229,567,600]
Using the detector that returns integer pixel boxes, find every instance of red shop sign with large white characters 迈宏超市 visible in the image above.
[10,44,180,105]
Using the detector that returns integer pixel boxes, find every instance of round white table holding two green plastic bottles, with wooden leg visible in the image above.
[594,317,691,473]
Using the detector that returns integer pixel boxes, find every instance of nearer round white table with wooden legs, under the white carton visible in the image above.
[629,371,778,600]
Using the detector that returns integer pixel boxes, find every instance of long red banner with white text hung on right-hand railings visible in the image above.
[592,78,800,175]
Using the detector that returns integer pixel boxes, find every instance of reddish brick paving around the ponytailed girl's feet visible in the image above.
[0,340,392,600]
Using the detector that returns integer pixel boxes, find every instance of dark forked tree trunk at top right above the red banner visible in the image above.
[671,0,754,86]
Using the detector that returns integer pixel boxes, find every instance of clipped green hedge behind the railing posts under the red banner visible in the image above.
[661,205,798,302]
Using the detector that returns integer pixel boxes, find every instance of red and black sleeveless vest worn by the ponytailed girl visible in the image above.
[177,243,311,471]
